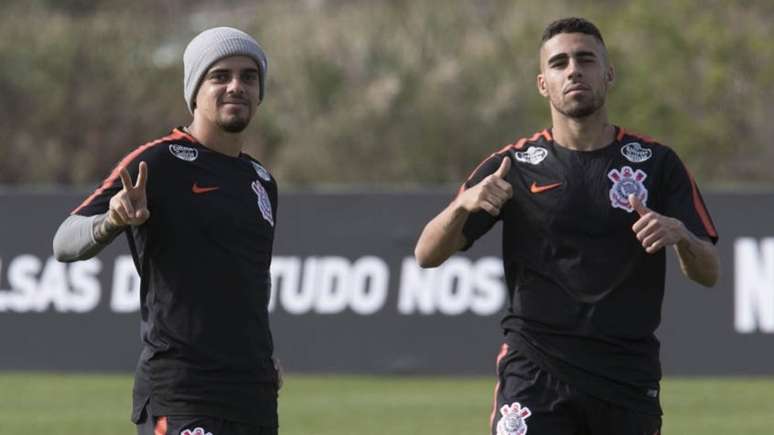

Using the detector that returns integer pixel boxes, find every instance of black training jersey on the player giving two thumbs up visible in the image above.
[461,128,717,413]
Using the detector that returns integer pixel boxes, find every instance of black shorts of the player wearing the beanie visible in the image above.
[137,405,278,435]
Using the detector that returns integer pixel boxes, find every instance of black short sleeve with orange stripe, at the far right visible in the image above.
[663,150,718,243]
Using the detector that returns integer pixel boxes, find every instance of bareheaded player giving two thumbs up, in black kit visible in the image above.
[415,18,719,435]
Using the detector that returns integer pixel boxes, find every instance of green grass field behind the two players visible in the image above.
[0,373,774,435]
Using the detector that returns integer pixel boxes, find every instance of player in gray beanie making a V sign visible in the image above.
[54,27,280,435]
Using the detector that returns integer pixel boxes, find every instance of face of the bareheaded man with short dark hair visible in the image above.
[537,33,614,119]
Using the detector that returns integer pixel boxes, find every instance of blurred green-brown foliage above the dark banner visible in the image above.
[0,0,774,186]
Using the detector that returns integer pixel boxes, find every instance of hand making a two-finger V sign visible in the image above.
[94,162,150,242]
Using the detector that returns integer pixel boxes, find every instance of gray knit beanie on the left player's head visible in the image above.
[183,27,269,113]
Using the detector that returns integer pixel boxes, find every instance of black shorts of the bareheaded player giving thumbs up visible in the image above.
[490,344,661,435]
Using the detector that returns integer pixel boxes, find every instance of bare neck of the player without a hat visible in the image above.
[551,108,615,151]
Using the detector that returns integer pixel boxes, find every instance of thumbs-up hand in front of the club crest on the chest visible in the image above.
[629,194,688,254]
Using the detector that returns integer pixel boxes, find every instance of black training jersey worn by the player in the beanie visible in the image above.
[73,129,277,426]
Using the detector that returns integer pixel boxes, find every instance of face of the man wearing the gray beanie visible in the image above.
[194,56,260,133]
